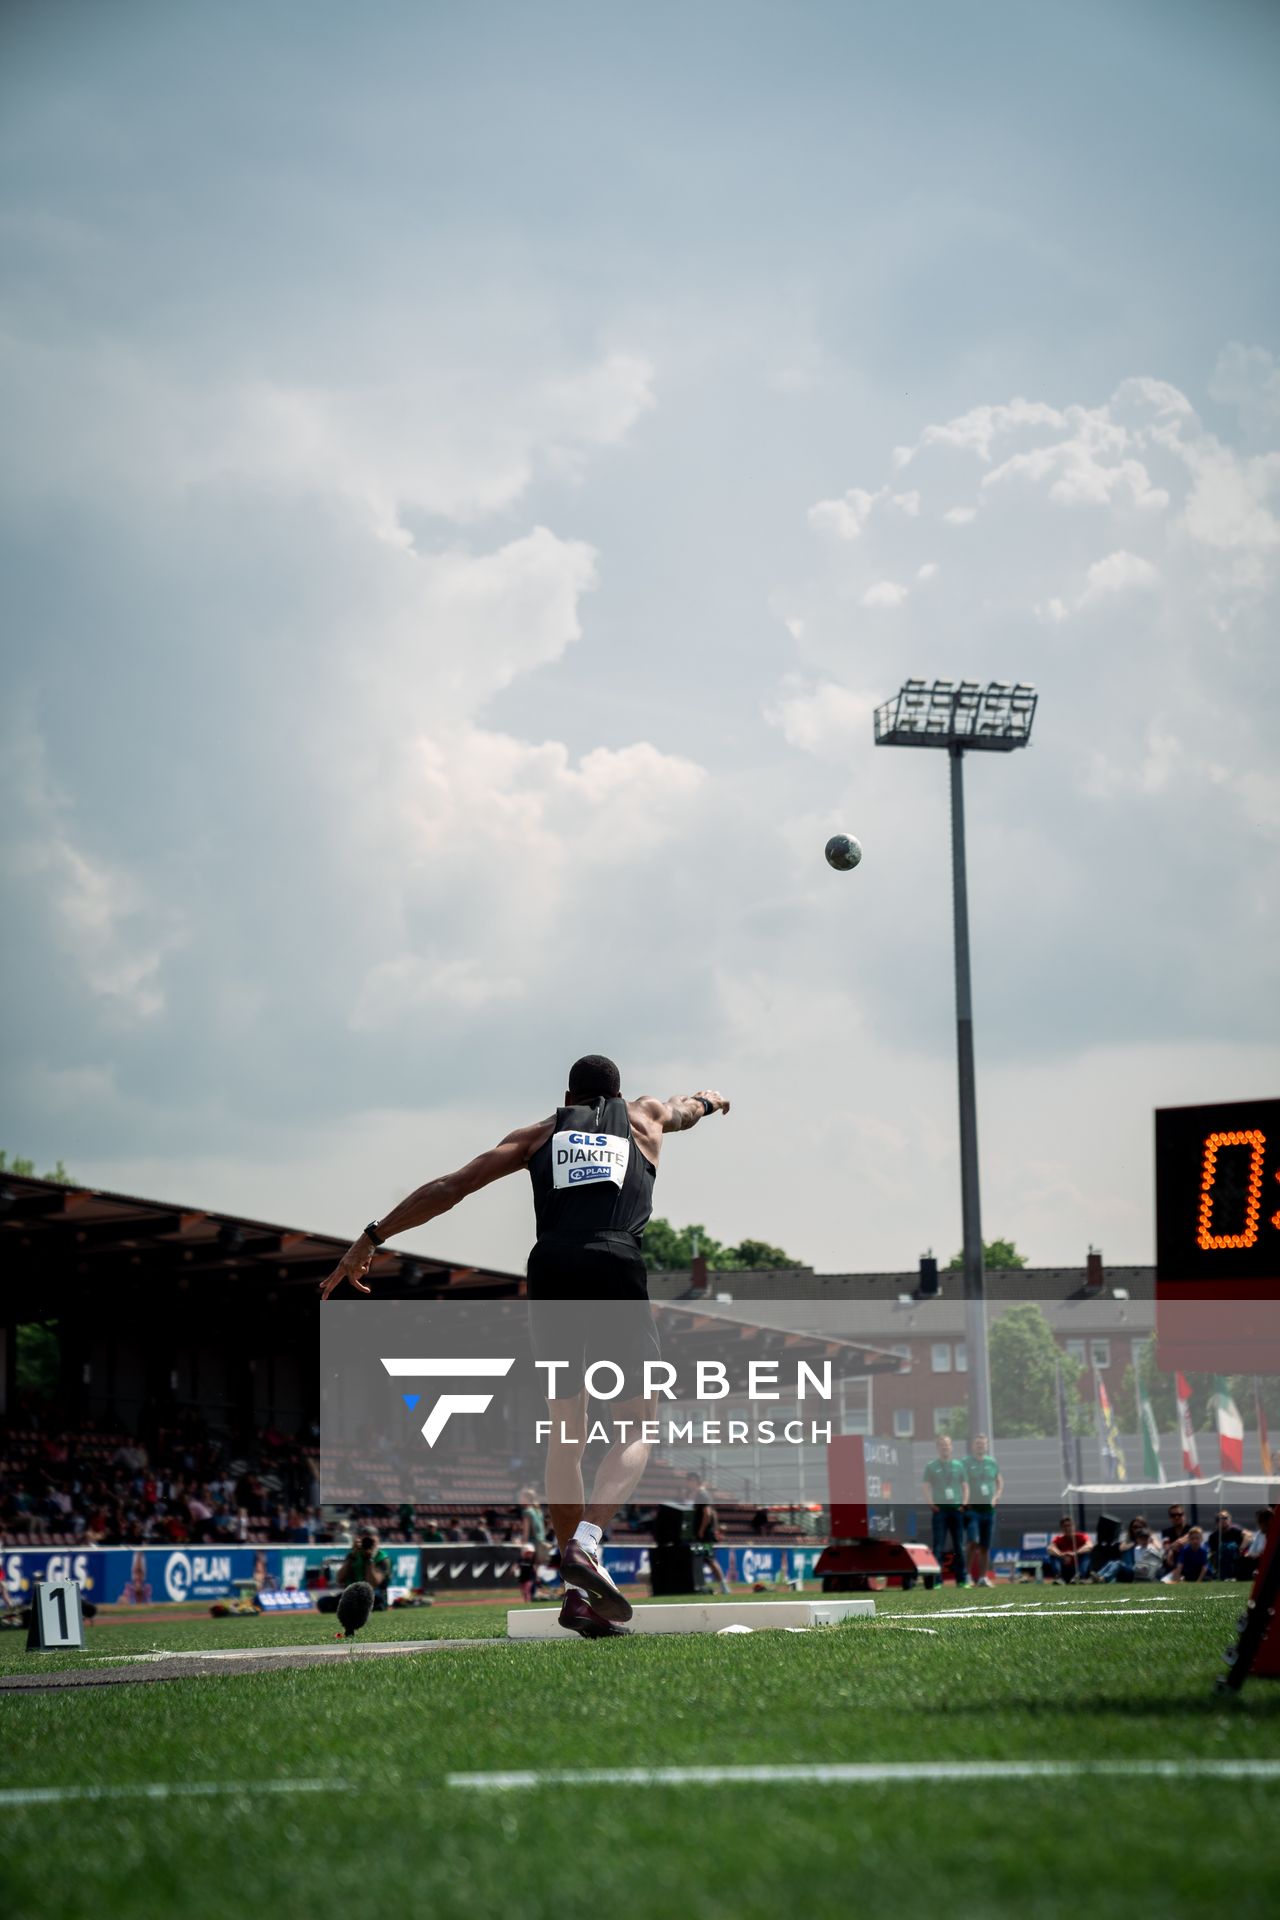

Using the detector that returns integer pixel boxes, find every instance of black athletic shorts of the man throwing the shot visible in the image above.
[528,1235,660,1417]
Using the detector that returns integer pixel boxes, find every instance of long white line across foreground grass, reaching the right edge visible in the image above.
[447,1761,1280,1793]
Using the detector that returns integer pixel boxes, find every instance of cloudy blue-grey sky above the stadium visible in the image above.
[0,0,1280,1271]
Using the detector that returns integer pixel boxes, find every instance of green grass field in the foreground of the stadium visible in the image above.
[0,1586,1280,1920]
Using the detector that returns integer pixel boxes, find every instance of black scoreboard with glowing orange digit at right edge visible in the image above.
[1155,1100,1280,1373]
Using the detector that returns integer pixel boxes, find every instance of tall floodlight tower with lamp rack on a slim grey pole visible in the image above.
[875,680,1038,1440]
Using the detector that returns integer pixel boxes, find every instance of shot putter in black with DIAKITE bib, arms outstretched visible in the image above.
[320,1054,729,1640]
